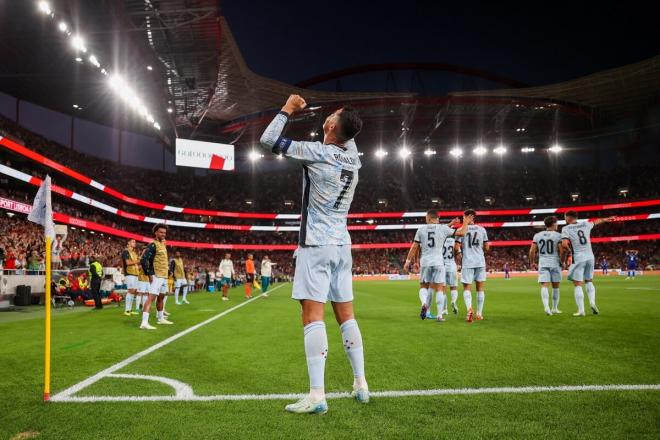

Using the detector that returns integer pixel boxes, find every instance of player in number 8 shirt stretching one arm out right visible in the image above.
[561,211,616,316]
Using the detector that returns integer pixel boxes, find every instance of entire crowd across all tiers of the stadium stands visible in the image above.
[0,117,660,276]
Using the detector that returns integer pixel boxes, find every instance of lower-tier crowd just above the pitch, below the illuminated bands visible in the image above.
[0,212,660,276]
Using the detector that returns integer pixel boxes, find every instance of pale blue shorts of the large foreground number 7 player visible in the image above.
[291,244,353,303]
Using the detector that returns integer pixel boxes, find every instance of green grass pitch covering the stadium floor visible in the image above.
[0,276,660,440]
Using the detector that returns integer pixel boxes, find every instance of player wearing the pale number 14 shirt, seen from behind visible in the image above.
[454,209,490,322]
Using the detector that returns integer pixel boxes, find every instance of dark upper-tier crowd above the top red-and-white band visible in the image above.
[0,117,660,217]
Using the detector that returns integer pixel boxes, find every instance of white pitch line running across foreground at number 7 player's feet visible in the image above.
[51,384,660,403]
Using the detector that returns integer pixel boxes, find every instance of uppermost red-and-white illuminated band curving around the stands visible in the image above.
[0,136,660,220]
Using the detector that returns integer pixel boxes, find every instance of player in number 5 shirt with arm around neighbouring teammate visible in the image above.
[403,210,469,322]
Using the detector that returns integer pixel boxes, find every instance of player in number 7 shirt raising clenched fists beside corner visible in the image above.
[261,95,369,414]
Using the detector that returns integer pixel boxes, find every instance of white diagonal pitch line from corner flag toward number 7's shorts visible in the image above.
[51,283,288,401]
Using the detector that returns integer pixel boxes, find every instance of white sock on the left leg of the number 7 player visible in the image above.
[304,321,328,400]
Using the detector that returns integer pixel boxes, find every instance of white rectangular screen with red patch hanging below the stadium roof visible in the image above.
[176,138,235,171]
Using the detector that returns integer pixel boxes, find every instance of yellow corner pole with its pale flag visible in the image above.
[28,176,55,402]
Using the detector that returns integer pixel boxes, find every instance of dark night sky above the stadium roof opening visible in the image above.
[220,0,660,85]
